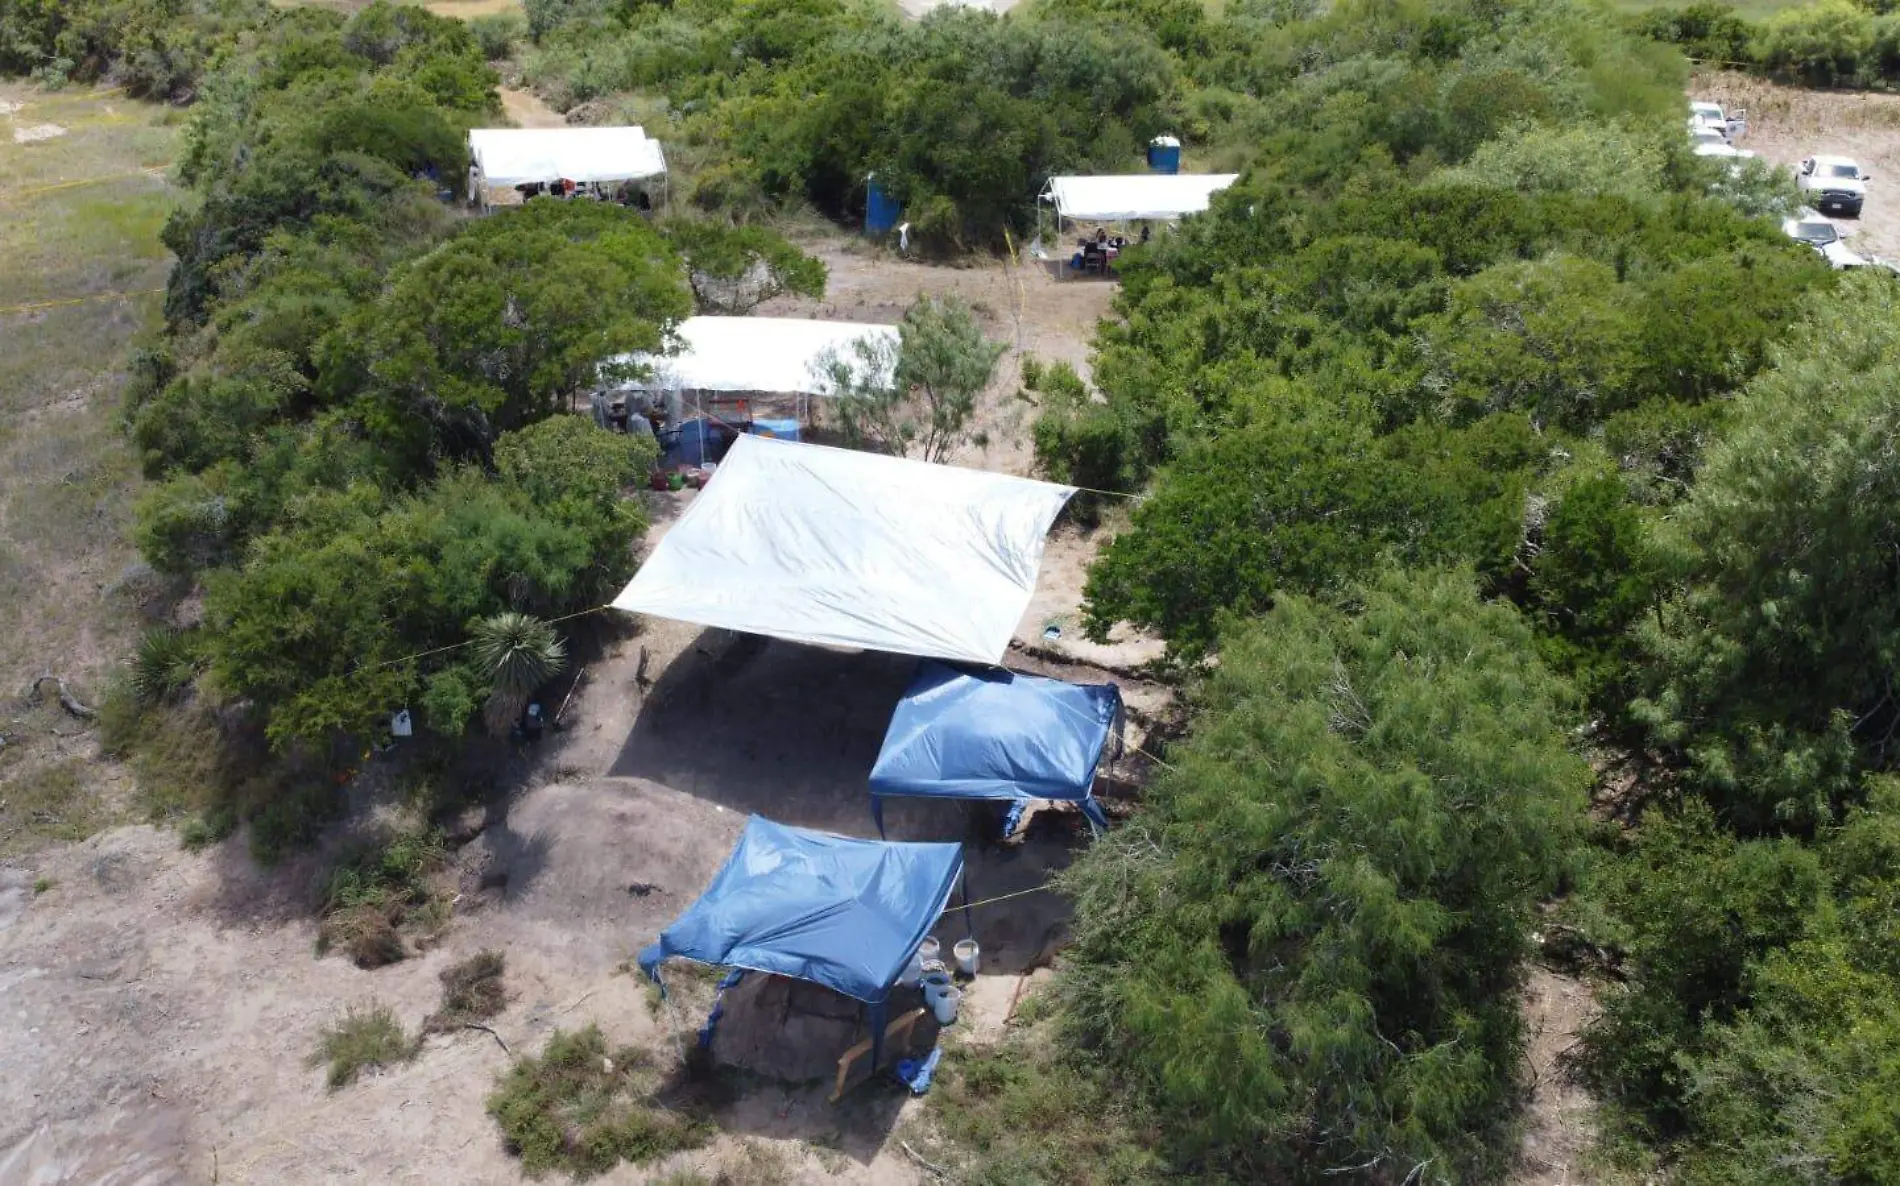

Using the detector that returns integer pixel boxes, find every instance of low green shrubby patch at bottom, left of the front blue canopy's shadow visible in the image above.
[488,1024,713,1178]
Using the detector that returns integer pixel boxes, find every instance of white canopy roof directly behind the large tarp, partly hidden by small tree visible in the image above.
[616,317,899,395]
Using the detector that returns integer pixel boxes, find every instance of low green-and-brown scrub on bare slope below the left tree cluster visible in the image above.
[321,821,454,975]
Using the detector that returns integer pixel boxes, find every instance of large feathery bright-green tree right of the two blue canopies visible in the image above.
[1062,572,1588,1182]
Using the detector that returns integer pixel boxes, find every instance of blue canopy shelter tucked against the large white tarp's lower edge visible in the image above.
[870,661,1121,834]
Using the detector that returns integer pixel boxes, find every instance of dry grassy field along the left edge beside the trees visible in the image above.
[0,84,177,853]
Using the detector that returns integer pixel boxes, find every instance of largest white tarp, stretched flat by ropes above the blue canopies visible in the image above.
[614,437,1075,663]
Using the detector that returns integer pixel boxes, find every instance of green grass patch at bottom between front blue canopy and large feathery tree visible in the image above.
[927,1030,1163,1186]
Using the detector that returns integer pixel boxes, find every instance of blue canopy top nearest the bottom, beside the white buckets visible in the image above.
[640,815,963,1004]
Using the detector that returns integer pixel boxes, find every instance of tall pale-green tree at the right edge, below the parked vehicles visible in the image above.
[1638,277,1900,827]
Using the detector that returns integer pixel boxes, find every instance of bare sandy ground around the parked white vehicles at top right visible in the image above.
[1689,72,1900,258]
